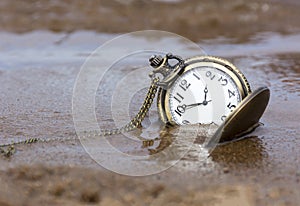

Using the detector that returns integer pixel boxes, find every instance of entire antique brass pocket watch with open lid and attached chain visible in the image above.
[0,53,270,156]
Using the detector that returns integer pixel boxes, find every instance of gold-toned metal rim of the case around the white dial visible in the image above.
[157,56,251,125]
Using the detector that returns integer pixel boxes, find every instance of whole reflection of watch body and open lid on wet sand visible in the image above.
[139,125,268,172]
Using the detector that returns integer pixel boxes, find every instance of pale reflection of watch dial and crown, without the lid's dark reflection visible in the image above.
[139,124,218,171]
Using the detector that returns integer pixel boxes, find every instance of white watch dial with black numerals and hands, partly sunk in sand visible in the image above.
[166,66,242,125]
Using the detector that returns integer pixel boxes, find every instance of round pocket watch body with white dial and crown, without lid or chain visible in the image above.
[149,54,251,125]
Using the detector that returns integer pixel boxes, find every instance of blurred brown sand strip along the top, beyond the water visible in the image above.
[0,0,300,41]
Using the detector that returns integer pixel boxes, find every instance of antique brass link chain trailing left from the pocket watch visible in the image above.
[0,77,159,157]
